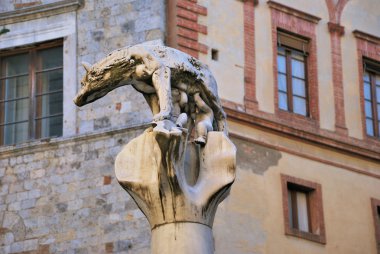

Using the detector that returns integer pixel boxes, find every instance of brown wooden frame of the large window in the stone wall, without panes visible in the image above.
[0,38,64,146]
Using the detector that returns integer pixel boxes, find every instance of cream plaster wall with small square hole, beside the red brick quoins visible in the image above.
[199,0,244,104]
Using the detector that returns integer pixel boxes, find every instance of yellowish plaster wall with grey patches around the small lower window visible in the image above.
[214,122,380,254]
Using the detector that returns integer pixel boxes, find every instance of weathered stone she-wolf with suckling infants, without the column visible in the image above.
[74,44,226,145]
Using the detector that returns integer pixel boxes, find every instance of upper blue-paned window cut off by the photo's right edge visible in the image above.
[363,60,380,137]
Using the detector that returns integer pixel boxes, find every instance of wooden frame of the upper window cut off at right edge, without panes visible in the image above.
[362,58,380,139]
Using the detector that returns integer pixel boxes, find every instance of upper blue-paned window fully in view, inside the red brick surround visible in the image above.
[277,31,309,116]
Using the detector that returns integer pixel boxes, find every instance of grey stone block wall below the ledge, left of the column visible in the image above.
[0,128,150,254]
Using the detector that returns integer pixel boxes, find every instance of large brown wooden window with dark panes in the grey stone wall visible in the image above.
[0,42,63,145]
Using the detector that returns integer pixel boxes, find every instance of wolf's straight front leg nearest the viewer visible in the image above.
[152,66,172,122]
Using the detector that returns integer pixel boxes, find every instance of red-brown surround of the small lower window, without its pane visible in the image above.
[281,174,326,244]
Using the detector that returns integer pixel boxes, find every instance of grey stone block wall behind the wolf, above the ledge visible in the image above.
[77,0,165,133]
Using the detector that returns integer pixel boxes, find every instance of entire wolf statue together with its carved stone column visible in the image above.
[74,44,236,254]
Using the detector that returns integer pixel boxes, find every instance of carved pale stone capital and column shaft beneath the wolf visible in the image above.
[115,128,236,254]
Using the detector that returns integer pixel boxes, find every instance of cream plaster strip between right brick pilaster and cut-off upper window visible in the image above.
[341,0,380,139]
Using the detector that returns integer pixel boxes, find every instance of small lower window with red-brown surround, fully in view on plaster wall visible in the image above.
[281,175,326,244]
